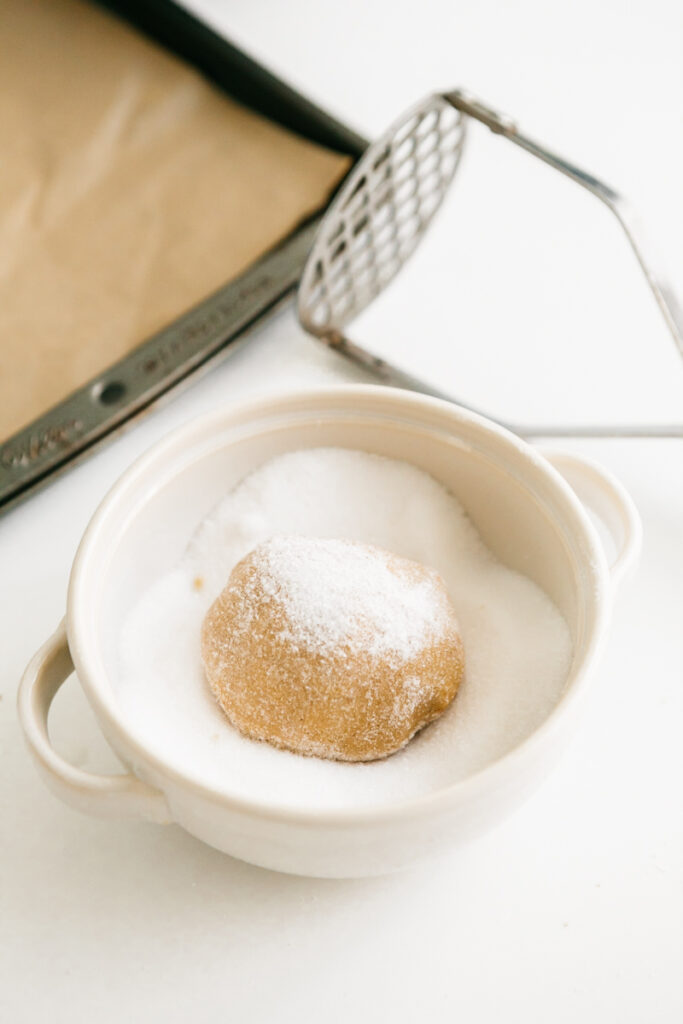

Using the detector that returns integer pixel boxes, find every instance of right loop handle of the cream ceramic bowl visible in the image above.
[543,449,643,586]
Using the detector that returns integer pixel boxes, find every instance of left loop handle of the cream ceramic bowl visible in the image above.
[17,622,171,824]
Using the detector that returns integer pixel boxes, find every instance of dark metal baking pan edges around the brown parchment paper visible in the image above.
[0,0,367,512]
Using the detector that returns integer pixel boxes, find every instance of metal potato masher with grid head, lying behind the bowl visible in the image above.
[297,89,683,437]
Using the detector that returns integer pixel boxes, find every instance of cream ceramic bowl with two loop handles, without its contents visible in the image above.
[18,386,640,878]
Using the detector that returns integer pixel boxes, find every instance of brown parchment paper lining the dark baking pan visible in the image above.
[0,0,348,439]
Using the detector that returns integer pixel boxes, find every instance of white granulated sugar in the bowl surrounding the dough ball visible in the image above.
[116,449,571,809]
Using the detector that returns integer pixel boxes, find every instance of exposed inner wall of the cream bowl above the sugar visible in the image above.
[69,389,595,798]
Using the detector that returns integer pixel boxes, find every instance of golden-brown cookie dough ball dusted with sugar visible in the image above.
[202,537,464,761]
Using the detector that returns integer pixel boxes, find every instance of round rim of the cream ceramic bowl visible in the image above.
[67,384,611,827]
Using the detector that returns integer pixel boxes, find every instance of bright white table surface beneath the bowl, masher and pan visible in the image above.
[0,0,683,1024]
